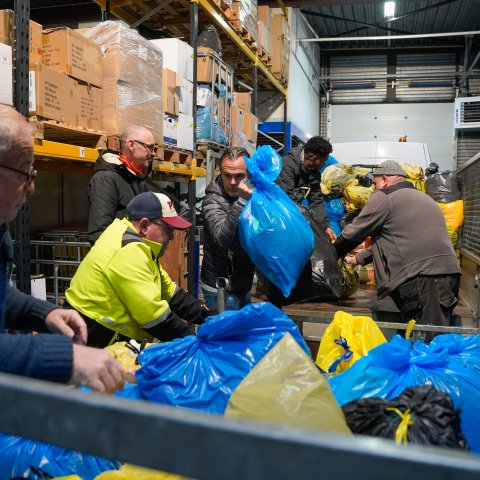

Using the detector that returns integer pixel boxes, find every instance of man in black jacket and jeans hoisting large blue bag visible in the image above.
[201,147,255,310]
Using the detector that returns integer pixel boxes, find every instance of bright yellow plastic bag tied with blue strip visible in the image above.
[315,310,387,375]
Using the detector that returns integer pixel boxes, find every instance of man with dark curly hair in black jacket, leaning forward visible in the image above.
[276,137,336,240]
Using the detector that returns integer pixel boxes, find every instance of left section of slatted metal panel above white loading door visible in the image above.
[329,55,387,104]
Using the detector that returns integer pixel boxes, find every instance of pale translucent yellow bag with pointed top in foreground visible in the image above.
[225,333,351,435]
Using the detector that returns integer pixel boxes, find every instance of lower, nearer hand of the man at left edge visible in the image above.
[70,345,128,393]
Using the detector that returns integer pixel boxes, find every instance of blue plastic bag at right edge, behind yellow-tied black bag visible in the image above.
[329,335,480,453]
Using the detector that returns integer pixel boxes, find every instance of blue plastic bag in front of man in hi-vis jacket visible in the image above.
[130,303,310,414]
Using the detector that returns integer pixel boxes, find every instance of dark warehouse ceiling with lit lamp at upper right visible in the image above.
[296,0,480,51]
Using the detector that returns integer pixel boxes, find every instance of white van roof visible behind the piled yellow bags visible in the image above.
[332,142,431,171]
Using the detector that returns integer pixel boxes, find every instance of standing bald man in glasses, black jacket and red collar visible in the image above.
[88,125,157,245]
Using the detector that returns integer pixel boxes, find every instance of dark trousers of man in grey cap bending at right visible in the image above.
[390,275,460,340]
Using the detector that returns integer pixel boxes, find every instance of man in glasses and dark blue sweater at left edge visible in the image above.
[0,105,124,392]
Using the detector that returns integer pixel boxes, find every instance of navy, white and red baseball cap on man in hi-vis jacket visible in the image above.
[127,192,192,230]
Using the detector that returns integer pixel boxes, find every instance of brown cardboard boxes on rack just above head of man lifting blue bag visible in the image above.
[232,92,258,152]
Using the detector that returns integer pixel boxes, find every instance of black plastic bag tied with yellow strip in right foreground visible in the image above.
[343,385,468,450]
